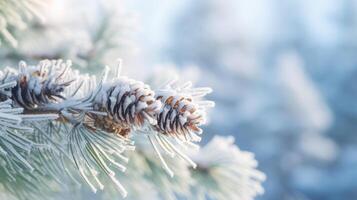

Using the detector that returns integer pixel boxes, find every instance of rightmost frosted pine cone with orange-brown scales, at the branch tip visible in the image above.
[155,82,214,141]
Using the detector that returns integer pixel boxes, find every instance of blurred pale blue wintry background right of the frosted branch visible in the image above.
[124,0,357,200]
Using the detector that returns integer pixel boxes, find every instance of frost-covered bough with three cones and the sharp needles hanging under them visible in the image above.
[0,60,214,196]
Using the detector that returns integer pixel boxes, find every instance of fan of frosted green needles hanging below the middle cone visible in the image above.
[68,126,134,197]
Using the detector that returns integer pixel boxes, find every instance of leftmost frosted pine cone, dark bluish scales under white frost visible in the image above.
[2,60,72,109]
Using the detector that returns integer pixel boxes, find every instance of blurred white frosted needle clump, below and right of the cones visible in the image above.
[191,136,265,200]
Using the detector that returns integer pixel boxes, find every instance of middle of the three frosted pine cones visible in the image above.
[93,77,161,135]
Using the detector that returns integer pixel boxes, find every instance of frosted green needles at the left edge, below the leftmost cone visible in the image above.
[0,81,57,199]
